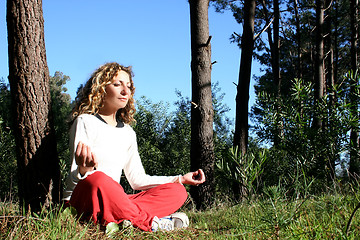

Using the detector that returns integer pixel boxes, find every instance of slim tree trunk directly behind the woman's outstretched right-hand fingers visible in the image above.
[189,0,215,209]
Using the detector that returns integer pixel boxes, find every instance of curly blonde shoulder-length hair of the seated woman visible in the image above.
[71,62,136,124]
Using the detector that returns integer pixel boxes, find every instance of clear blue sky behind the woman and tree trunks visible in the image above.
[0,0,259,122]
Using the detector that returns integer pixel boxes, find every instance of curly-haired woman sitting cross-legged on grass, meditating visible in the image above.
[64,63,205,231]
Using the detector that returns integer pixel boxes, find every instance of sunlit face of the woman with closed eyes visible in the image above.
[104,71,131,112]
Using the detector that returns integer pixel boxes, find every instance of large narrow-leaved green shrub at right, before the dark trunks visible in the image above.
[253,79,358,191]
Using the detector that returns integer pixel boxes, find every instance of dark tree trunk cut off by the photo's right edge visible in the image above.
[349,0,360,177]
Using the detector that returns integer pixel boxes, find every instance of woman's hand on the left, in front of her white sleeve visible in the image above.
[75,142,98,176]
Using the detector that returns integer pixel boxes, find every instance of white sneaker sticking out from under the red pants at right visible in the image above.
[151,212,189,232]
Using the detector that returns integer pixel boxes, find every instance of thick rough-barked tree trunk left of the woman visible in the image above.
[7,0,61,211]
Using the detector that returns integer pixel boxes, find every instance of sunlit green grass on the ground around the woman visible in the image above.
[0,192,360,239]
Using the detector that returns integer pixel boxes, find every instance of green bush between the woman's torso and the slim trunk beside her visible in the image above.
[131,92,190,191]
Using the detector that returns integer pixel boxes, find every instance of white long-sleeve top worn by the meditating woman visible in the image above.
[63,114,179,200]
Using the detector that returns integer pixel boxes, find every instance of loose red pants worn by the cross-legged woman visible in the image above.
[70,172,187,231]
